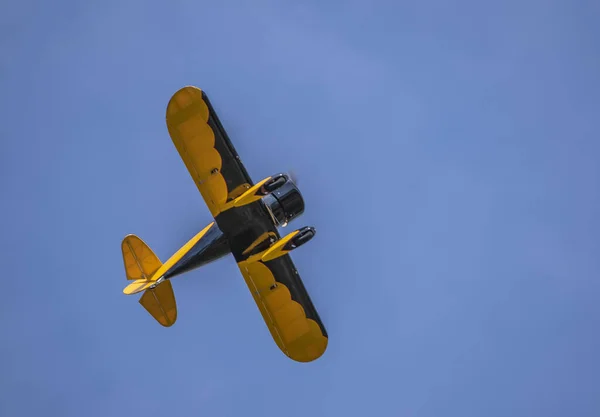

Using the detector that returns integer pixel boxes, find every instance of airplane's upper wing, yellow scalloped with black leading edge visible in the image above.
[166,86,254,217]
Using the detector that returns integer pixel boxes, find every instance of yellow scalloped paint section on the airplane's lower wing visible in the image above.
[238,260,328,362]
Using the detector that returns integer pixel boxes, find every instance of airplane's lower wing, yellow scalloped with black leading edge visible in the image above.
[238,250,328,362]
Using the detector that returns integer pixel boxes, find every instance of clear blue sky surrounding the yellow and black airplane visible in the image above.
[0,0,600,417]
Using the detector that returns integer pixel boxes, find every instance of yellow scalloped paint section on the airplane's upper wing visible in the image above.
[166,86,229,217]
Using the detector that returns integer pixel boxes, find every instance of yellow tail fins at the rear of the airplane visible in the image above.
[121,235,177,327]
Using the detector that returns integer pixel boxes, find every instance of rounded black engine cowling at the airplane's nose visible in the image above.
[260,174,304,227]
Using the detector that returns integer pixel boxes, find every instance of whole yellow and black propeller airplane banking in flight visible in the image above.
[121,86,328,362]
